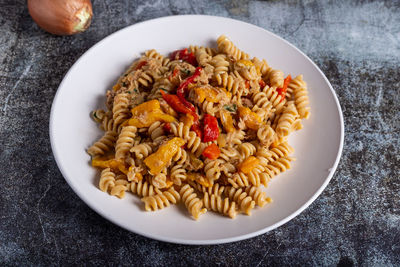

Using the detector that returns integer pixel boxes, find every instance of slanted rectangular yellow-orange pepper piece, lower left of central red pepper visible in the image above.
[144,137,185,175]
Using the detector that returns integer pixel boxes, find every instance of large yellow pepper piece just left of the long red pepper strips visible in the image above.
[129,99,175,128]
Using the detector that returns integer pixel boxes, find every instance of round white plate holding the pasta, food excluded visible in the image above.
[50,15,344,244]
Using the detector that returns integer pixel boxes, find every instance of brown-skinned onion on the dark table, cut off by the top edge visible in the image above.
[28,0,93,35]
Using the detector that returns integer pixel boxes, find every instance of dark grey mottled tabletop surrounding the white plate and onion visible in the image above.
[0,0,400,266]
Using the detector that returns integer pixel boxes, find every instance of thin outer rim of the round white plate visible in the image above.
[49,14,344,245]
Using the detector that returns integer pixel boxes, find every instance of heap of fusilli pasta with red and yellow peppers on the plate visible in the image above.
[87,35,310,220]
